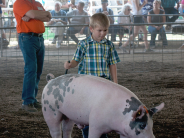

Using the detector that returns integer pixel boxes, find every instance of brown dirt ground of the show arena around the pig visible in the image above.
[0,43,184,138]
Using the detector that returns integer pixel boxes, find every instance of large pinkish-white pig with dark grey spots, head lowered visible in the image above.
[42,74,164,138]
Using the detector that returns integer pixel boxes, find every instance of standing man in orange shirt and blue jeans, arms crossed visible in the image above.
[13,0,51,112]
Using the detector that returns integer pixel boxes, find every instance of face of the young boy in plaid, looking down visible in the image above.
[89,26,108,42]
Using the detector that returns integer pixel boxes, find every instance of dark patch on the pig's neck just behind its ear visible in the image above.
[123,97,142,115]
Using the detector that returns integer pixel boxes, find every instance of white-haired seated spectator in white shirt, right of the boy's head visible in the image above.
[117,3,132,46]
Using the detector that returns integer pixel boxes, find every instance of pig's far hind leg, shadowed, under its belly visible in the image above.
[62,119,74,138]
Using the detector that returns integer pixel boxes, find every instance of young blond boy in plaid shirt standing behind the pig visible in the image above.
[64,13,120,138]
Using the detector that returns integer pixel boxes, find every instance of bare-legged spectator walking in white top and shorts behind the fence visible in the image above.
[120,0,152,52]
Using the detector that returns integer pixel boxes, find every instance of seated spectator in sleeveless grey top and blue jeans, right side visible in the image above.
[147,0,167,48]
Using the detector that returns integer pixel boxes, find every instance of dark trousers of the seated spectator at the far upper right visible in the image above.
[164,7,179,22]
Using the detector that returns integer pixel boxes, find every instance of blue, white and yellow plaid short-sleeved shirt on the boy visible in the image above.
[73,36,120,78]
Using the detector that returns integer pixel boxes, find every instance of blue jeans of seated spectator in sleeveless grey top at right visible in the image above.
[148,26,167,46]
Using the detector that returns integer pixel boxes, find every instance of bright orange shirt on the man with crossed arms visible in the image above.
[13,0,45,33]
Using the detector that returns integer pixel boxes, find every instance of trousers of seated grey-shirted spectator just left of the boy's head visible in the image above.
[67,27,88,44]
